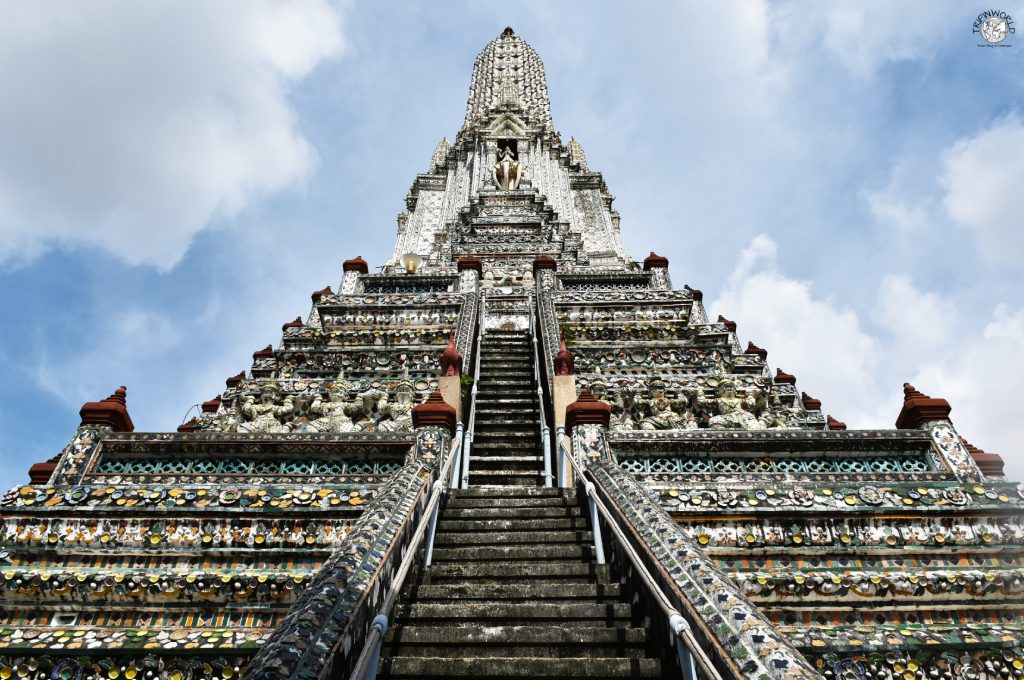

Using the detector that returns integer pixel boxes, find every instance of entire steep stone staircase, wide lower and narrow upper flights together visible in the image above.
[379,332,663,679]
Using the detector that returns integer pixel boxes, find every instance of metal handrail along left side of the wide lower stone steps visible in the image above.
[349,430,462,680]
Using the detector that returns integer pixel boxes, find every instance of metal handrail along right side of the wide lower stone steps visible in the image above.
[558,436,722,680]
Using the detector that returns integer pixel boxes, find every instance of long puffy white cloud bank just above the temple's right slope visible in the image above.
[710,241,1024,478]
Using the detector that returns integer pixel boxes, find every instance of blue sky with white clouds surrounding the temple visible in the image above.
[0,0,1024,487]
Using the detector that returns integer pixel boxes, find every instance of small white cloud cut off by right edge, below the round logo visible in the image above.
[939,114,1024,265]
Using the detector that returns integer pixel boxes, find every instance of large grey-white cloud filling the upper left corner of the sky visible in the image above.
[0,0,343,268]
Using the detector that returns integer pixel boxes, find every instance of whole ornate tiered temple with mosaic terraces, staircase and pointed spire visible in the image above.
[0,29,1024,680]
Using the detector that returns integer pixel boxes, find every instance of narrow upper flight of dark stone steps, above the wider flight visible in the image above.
[469,331,544,486]
